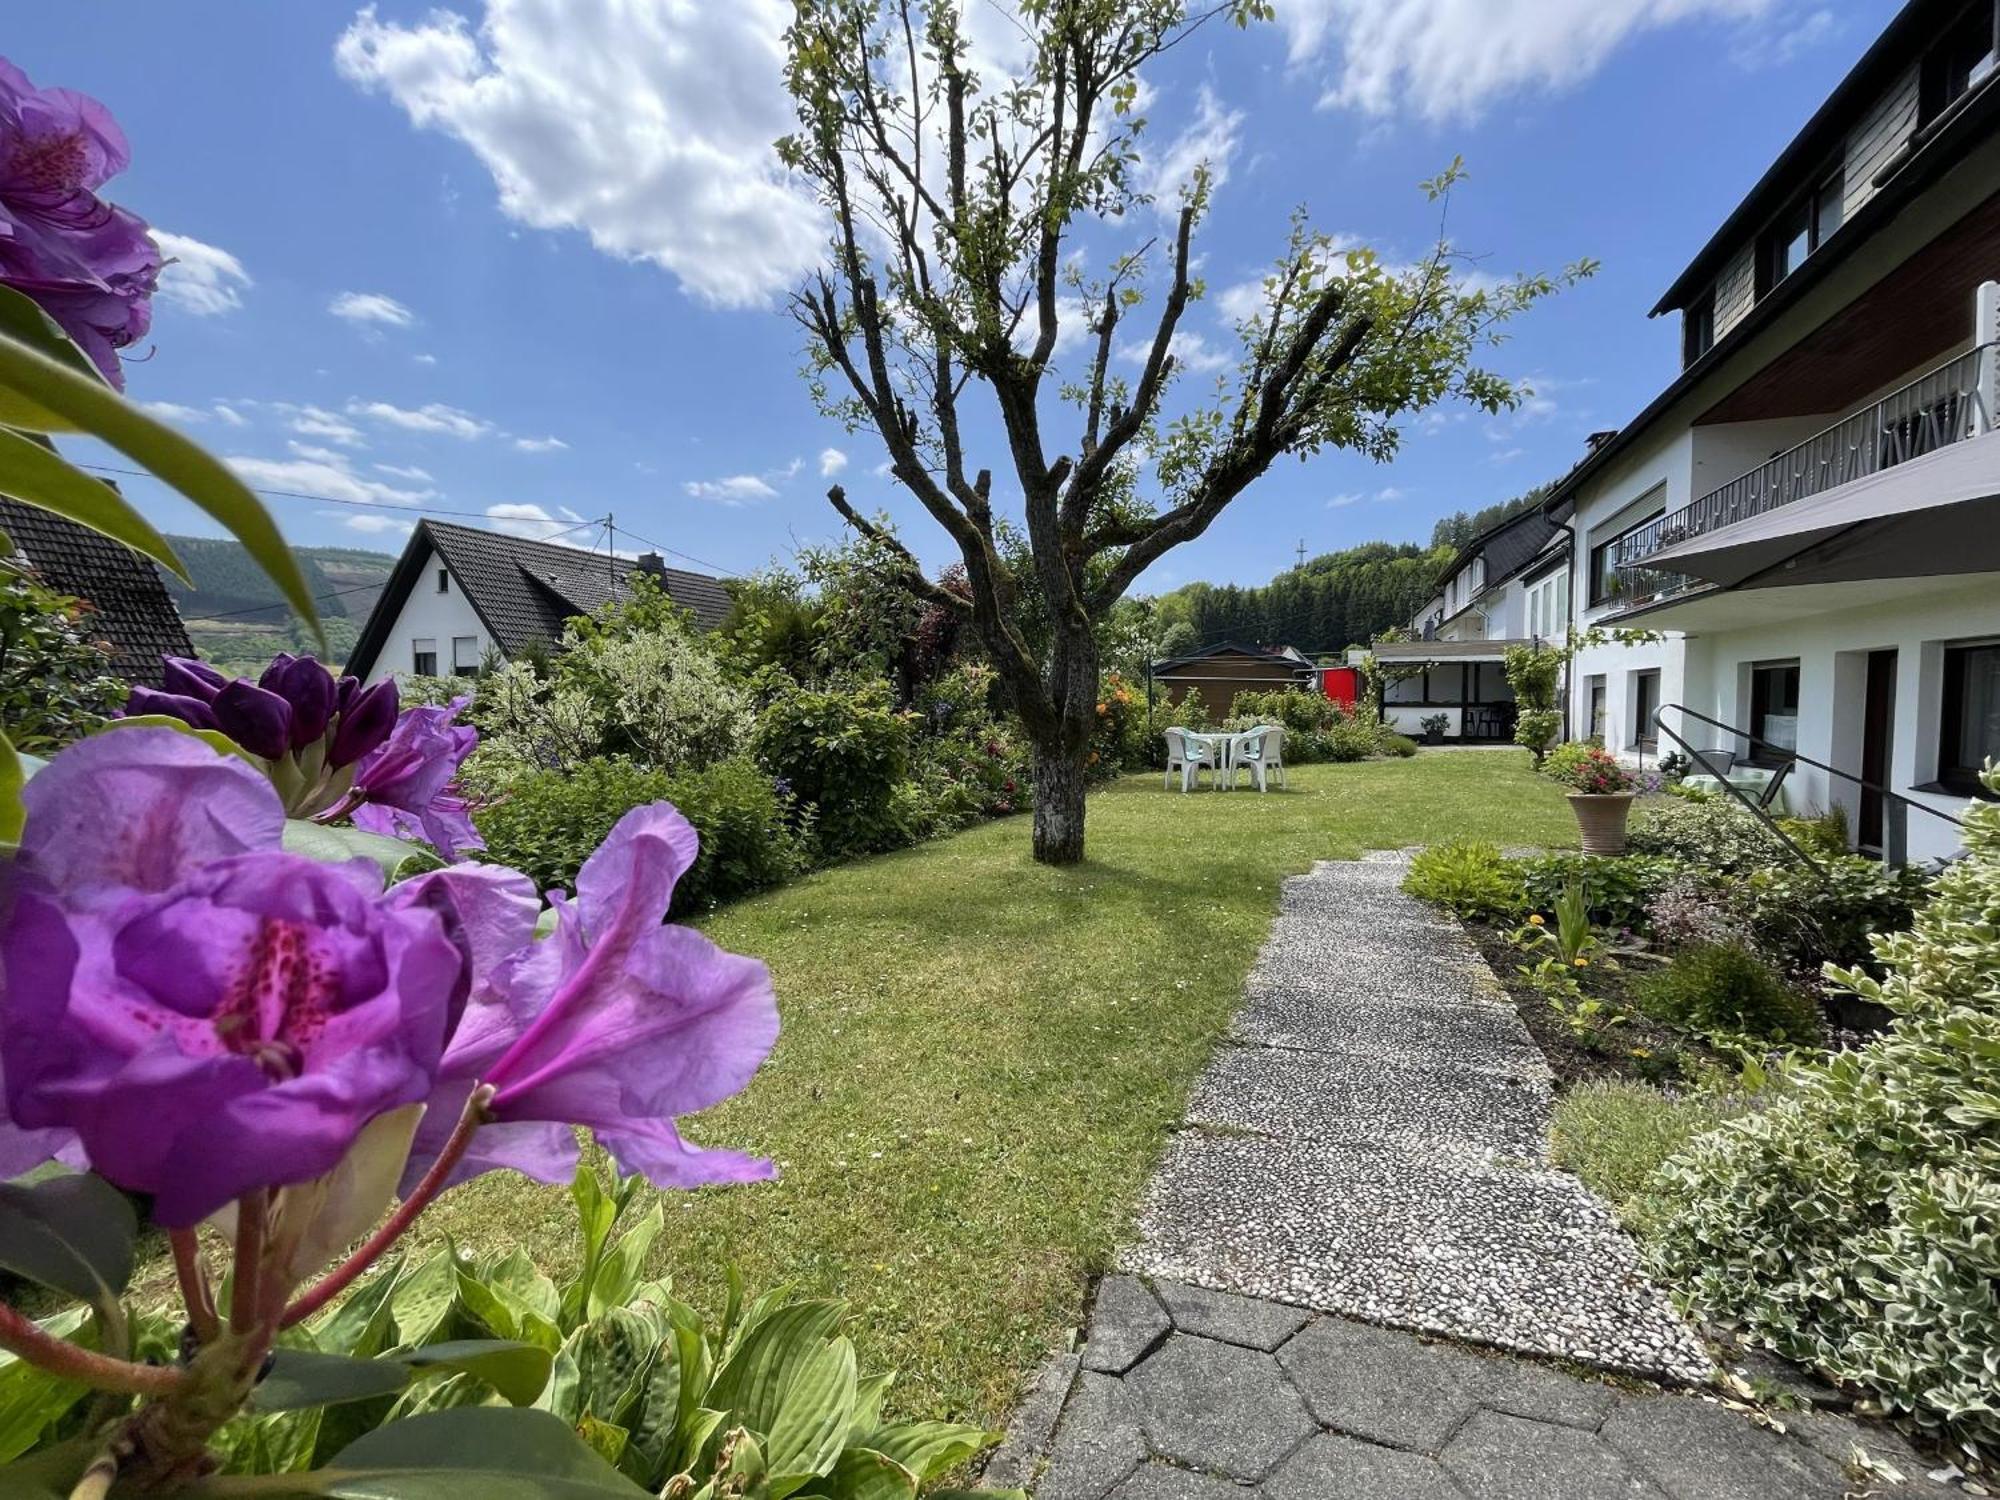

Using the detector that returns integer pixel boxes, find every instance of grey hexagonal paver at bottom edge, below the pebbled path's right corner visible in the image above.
[1602,1396,1848,1500]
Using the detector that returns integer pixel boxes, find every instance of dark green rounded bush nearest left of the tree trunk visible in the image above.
[752,682,910,860]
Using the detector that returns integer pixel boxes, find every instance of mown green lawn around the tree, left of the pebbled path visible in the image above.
[426,752,1576,1422]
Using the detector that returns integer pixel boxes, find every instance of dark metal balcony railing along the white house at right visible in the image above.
[1616,346,1996,608]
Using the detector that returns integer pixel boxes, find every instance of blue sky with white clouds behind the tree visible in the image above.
[6,0,1894,588]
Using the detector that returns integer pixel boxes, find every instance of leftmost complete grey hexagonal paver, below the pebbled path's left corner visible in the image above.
[1126,1334,1314,1480]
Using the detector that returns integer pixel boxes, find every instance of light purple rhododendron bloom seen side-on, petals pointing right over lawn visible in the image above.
[404,802,778,1188]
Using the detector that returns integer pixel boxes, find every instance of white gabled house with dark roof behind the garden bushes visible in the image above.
[346,520,730,682]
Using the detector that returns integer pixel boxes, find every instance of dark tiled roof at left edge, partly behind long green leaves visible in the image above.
[0,498,194,686]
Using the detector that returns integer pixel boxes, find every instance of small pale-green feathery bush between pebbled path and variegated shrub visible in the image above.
[1548,1078,1742,1234]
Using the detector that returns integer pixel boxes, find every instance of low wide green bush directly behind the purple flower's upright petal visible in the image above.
[474,760,806,916]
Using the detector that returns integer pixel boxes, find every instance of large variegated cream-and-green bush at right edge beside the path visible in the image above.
[1648,772,2000,1458]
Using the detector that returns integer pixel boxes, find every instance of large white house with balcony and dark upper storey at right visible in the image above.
[1546,0,2000,858]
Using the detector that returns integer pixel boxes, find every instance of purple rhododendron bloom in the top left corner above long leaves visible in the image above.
[0,58,162,390]
